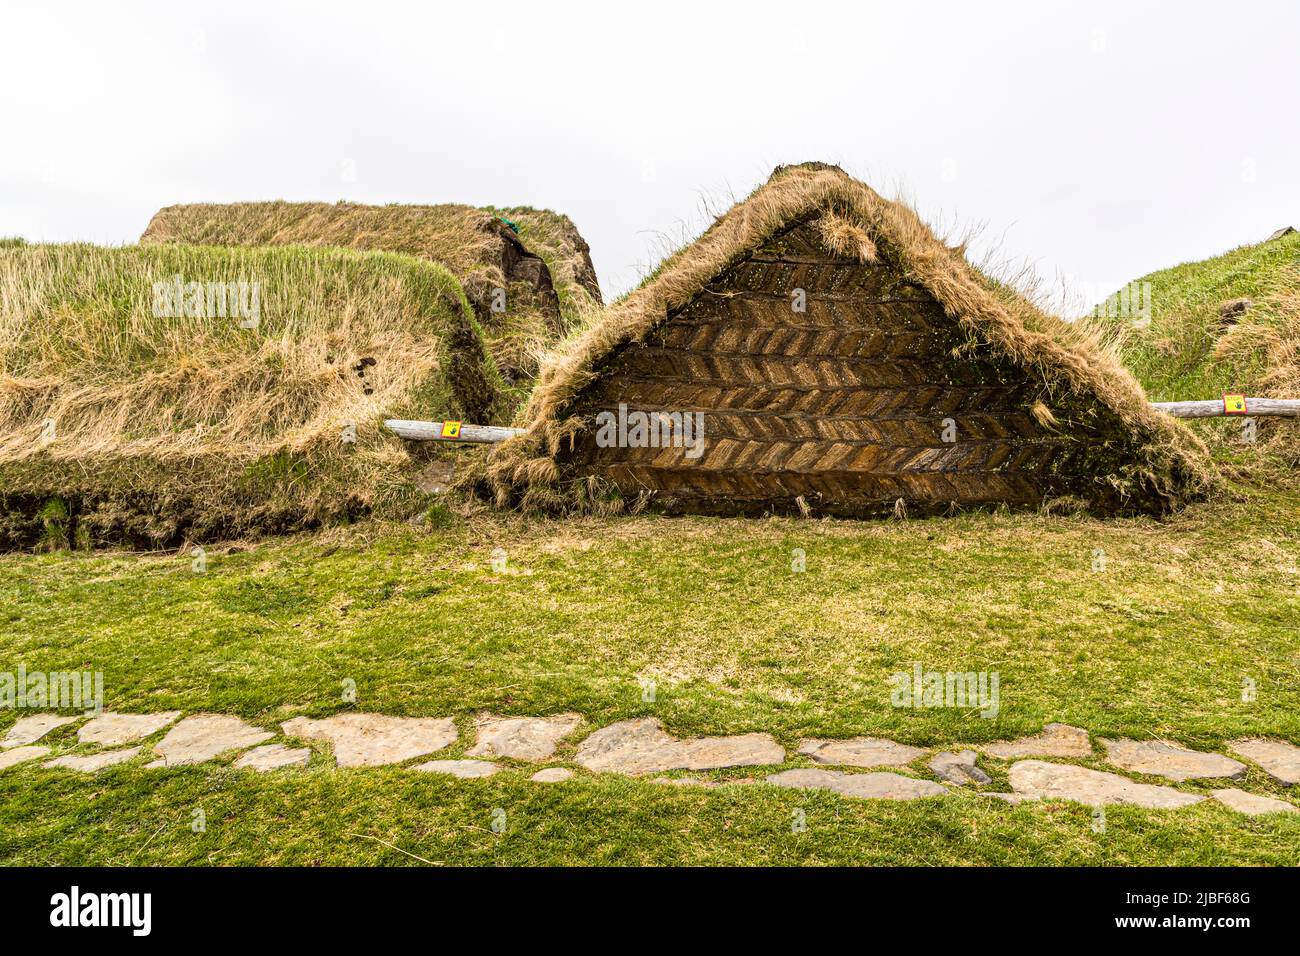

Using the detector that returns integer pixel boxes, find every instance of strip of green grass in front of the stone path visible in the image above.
[10,769,1300,866]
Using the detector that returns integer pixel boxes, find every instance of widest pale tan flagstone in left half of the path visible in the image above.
[281,714,456,767]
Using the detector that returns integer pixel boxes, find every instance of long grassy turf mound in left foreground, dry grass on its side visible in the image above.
[0,245,497,549]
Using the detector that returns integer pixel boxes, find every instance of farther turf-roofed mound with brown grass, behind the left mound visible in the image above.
[140,202,601,401]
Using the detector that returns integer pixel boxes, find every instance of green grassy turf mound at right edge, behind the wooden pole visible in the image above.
[1096,233,1300,463]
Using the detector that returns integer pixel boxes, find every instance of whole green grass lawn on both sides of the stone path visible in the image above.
[0,488,1300,865]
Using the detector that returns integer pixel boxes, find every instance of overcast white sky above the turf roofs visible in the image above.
[0,0,1300,310]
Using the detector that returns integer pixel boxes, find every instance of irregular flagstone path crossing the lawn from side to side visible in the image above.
[0,711,1300,816]
